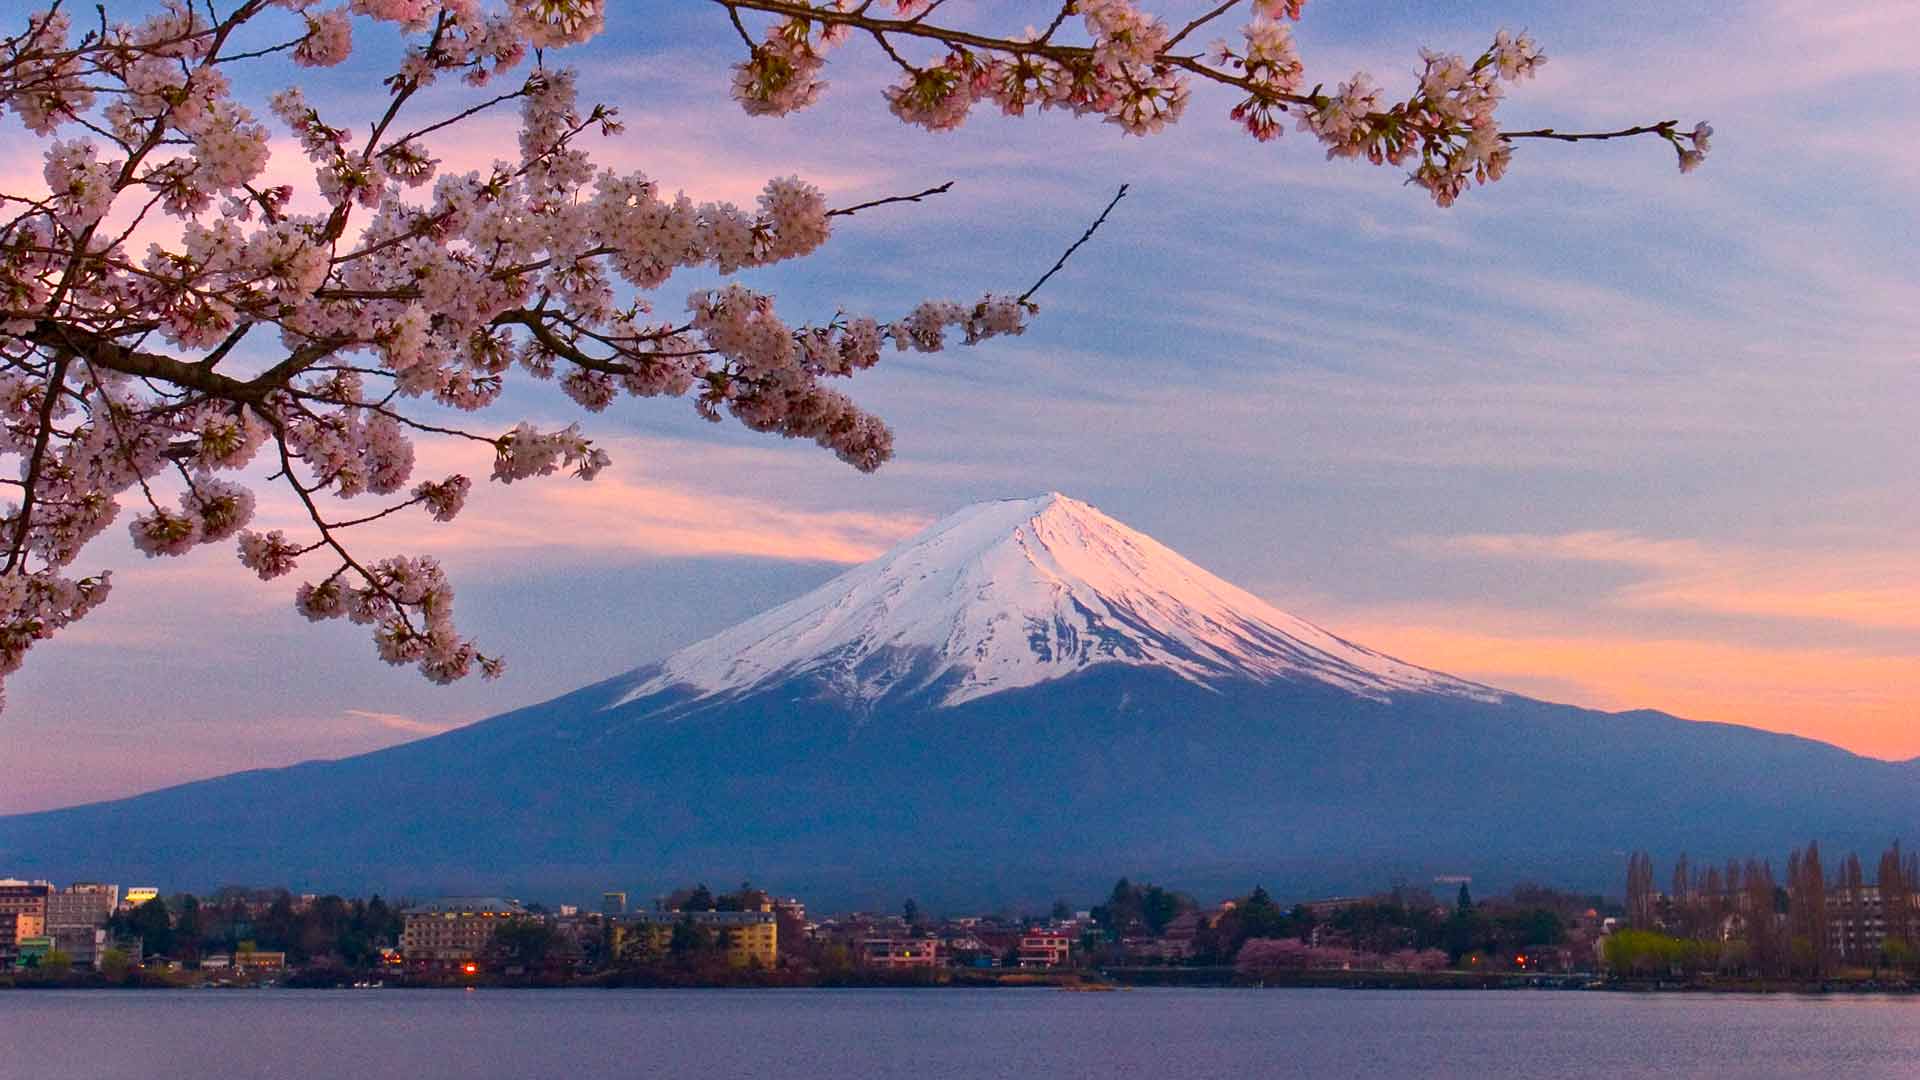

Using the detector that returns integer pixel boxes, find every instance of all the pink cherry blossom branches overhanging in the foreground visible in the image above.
[0,0,1711,703]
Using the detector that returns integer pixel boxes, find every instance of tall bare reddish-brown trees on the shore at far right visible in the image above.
[1605,842,1920,978]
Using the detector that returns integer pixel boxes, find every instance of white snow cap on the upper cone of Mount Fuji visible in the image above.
[618,492,1501,705]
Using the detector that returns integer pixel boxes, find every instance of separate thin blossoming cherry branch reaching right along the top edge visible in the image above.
[712,0,1713,189]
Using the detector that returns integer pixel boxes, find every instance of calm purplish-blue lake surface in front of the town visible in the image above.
[0,990,1920,1080]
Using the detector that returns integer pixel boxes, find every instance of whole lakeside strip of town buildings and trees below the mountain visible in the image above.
[0,844,1920,990]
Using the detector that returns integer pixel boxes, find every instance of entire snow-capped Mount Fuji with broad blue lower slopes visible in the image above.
[0,494,1920,909]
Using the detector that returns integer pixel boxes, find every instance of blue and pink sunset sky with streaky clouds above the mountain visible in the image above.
[0,0,1920,813]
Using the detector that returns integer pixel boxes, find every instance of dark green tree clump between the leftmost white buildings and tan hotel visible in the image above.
[108,888,401,967]
